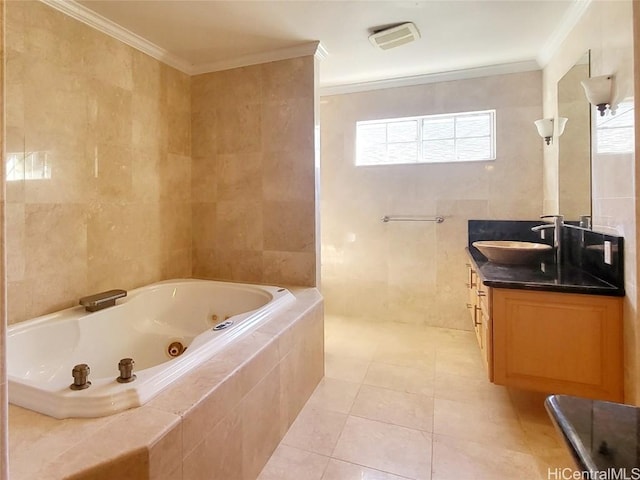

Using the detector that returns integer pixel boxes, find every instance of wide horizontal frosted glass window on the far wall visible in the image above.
[356,110,496,165]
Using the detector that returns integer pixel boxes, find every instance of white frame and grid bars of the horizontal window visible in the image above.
[354,109,497,167]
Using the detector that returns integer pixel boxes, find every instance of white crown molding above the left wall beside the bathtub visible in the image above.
[40,0,192,74]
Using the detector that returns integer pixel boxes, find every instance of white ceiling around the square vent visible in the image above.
[72,0,588,92]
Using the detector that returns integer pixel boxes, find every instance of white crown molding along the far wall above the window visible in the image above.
[319,60,540,97]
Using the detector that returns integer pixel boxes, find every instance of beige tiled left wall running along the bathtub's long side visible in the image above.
[6,1,191,323]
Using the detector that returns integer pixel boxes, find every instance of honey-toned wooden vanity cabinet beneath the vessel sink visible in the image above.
[467,265,623,401]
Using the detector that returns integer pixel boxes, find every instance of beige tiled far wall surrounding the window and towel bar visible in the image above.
[321,72,543,329]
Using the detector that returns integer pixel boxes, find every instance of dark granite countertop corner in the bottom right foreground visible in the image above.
[545,395,640,472]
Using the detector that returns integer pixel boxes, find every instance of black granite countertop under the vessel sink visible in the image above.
[467,247,624,297]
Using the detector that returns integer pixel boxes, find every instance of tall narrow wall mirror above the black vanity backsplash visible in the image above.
[557,52,591,220]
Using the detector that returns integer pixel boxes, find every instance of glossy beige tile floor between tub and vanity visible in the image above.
[259,316,571,480]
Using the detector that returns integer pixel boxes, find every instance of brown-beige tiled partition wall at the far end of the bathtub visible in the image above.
[191,56,317,286]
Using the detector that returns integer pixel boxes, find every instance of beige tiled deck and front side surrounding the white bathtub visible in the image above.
[10,288,324,480]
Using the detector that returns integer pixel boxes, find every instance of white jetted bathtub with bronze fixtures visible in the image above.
[7,280,294,418]
